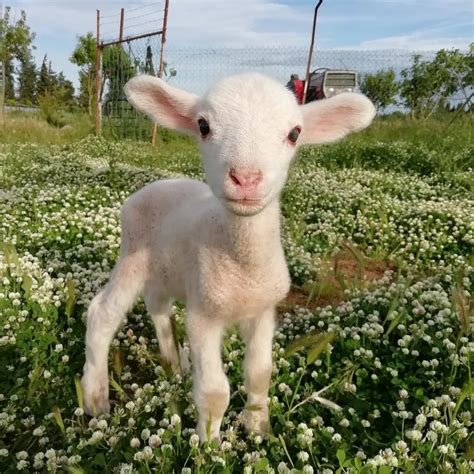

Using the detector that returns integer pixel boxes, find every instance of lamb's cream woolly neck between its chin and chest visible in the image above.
[227,201,282,267]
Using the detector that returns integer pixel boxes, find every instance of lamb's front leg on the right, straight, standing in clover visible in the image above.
[241,309,275,433]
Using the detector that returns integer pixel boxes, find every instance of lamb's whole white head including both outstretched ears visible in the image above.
[125,74,375,216]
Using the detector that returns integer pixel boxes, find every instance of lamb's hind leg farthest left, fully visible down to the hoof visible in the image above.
[81,256,143,416]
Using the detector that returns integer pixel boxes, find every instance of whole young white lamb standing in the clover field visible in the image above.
[82,74,375,441]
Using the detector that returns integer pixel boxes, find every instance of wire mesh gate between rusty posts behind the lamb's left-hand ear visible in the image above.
[96,0,168,140]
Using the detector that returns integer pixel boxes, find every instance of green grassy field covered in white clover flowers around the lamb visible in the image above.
[0,113,474,474]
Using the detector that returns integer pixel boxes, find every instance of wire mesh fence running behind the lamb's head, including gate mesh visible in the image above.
[102,46,461,140]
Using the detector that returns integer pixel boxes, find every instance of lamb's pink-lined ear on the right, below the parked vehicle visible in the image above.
[298,92,375,144]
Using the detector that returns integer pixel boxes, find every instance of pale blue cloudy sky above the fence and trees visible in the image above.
[4,0,474,91]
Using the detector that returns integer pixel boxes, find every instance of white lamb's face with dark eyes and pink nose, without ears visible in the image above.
[195,74,303,215]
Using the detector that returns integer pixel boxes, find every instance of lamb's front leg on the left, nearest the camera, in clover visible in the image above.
[186,311,230,442]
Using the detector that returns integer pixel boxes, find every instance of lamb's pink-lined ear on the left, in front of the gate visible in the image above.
[124,76,198,133]
